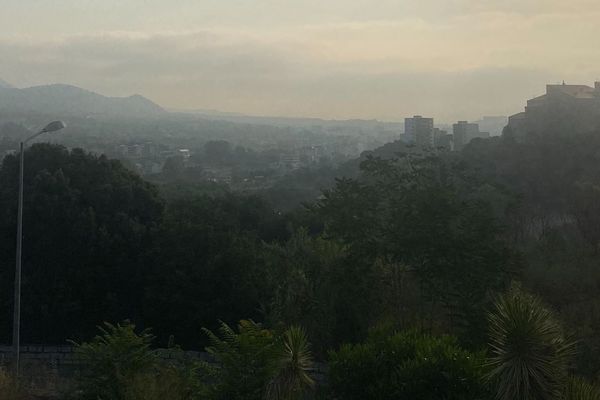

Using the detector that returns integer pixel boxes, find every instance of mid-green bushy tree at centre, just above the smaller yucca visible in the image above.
[264,229,377,356]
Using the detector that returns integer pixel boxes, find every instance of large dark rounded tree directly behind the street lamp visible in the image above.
[0,144,163,343]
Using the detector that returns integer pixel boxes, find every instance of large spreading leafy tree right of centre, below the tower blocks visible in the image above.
[319,155,512,341]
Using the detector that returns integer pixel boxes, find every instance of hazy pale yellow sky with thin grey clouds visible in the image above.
[0,0,600,122]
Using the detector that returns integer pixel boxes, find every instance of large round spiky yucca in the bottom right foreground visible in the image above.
[488,286,575,400]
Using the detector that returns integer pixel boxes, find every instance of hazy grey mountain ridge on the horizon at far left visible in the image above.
[0,81,166,117]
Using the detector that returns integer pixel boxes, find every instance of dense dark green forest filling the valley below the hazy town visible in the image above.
[0,133,600,399]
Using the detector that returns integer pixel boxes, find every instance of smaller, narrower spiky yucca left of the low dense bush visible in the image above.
[266,326,315,400]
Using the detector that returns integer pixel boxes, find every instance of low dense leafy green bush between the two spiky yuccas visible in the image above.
[329,332,489,400]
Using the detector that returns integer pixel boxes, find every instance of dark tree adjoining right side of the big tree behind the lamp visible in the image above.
[144,194,285,346]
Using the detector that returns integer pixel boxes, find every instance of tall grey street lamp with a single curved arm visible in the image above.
[13,121,66,378]
